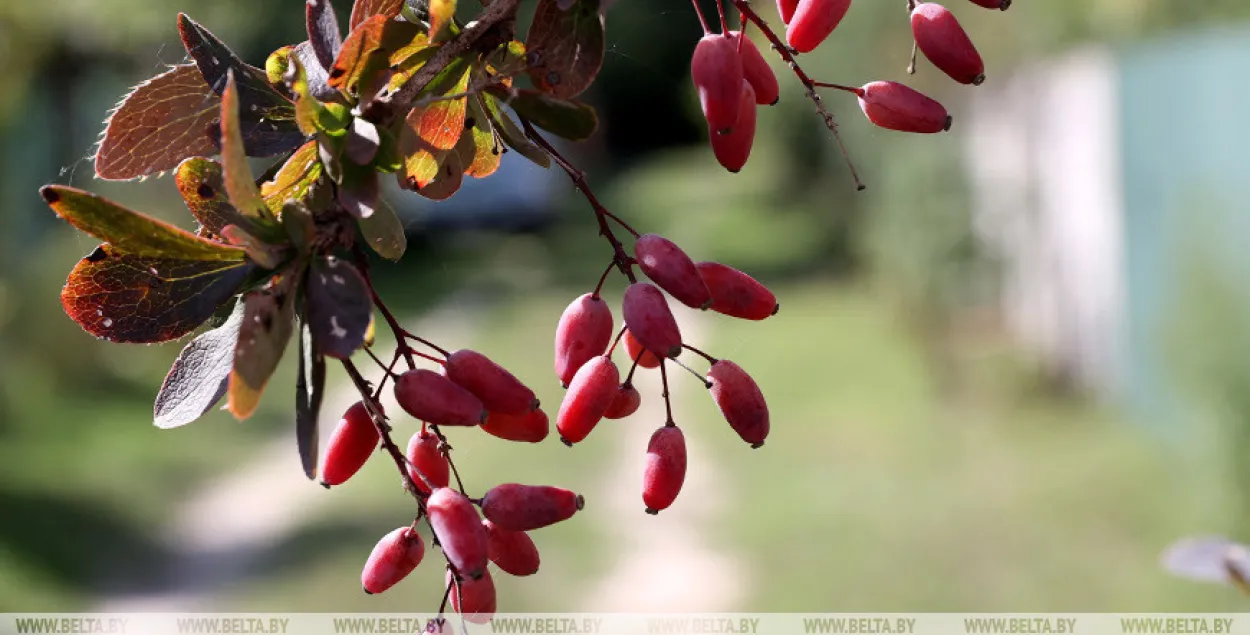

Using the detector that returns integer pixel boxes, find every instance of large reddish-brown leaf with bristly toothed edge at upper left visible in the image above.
[95,65,219,180]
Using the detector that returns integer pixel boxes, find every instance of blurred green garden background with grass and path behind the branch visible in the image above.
[0,0,1250,611]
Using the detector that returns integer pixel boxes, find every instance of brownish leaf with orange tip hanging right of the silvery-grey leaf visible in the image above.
[226,275,298,420]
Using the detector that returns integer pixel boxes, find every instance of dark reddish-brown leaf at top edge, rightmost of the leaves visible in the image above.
[525,0,604,99]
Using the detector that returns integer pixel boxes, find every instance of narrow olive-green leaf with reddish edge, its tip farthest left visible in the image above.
[39,185,245,263]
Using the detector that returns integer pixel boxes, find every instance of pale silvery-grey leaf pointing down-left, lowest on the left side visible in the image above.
[153,304,243,429]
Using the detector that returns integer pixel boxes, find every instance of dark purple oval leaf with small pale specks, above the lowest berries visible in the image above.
[305,256,374,360]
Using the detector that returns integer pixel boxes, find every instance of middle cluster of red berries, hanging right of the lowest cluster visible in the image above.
[555,234,779,514]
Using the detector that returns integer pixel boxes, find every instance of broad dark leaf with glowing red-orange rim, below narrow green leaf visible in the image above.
[61,244,254,344]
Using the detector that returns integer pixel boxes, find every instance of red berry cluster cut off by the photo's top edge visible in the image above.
[690,0,1011,173]
